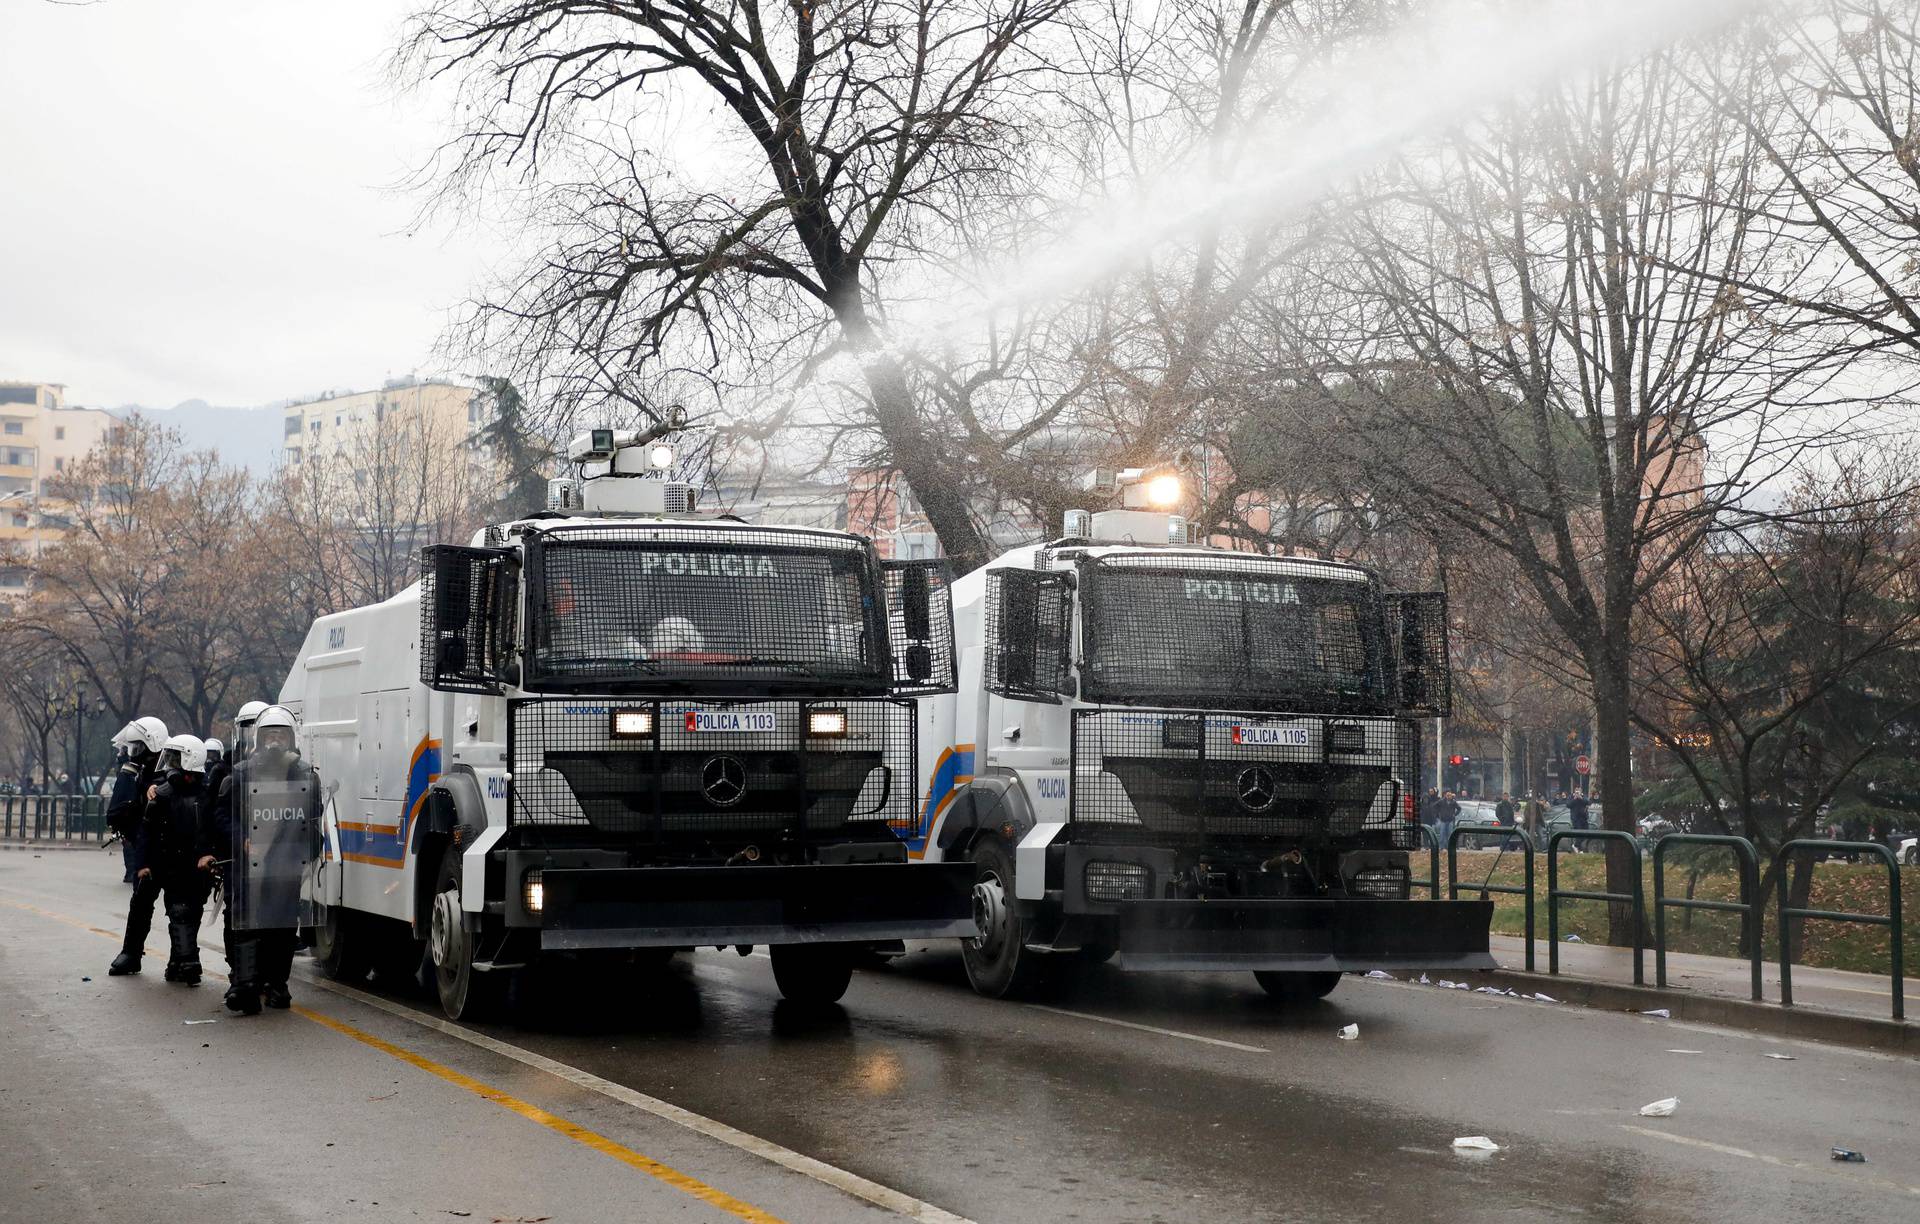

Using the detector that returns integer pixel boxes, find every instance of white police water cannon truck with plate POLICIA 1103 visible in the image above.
[280,420,977,1019]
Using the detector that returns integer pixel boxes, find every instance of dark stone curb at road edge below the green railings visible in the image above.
[1463,969,1920,1053]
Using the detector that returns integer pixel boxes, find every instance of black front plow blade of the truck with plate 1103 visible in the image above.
[540,863,979,950]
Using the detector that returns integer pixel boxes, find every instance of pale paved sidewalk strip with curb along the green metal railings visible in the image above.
[1478,934,1920,1053]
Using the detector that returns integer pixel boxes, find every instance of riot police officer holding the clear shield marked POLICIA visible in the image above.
[200,706,321,1015]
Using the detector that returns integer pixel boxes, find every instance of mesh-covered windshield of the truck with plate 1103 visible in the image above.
[528,526,893,693]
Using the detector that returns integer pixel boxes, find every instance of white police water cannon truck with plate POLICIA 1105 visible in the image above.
[910,466,1494,1000]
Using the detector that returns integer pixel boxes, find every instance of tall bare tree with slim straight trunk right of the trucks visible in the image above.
[1279,38,1889,940]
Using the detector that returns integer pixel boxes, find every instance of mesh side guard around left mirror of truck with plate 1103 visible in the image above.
[420,545,518,693]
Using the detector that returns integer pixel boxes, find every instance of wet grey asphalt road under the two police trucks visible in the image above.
[0,852,1920,1224]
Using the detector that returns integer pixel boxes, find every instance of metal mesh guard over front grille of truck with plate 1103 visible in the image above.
[507,698,920,842]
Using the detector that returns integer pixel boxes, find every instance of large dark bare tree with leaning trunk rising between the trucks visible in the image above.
[403,0,1064,566]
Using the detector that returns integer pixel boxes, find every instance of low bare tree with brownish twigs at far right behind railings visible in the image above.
[1634,453,1920,901]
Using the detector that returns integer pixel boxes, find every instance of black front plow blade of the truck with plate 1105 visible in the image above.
[1114,900,1498,973]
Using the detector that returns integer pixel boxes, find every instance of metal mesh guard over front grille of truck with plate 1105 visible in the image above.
[1068,710,1419,848]
